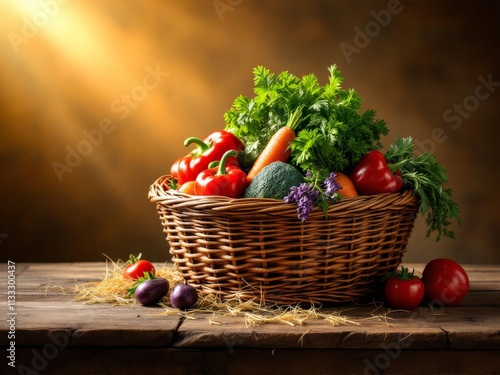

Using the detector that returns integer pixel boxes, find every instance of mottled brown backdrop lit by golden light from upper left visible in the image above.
[0,0,500,263]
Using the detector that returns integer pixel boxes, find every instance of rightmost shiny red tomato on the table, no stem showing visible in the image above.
[422,258,469,306]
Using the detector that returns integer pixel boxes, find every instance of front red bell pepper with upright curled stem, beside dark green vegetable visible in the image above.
[194,150,247,198]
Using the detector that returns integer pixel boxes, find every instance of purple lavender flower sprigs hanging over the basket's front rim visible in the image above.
[284,172,342,222]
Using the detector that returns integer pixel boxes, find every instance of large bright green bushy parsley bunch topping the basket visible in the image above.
[224,65,388,181]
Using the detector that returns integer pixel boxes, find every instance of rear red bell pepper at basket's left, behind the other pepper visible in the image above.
[170,130,245,185]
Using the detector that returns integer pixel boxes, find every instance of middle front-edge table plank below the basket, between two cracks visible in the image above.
[174,318,447,349]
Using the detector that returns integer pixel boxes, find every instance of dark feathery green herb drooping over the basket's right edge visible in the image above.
[385,137,460,241]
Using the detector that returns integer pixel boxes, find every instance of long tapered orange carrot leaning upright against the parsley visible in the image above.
[247,106,303,185]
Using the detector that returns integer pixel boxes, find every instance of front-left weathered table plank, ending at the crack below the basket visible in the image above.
[0,301,180,346]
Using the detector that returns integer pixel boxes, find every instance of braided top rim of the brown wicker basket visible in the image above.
[148,175,419,218]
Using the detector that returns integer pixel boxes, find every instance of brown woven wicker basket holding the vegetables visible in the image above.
[149,176,419,304]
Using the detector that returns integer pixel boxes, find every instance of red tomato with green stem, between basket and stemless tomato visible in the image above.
[385,267,424,310]
